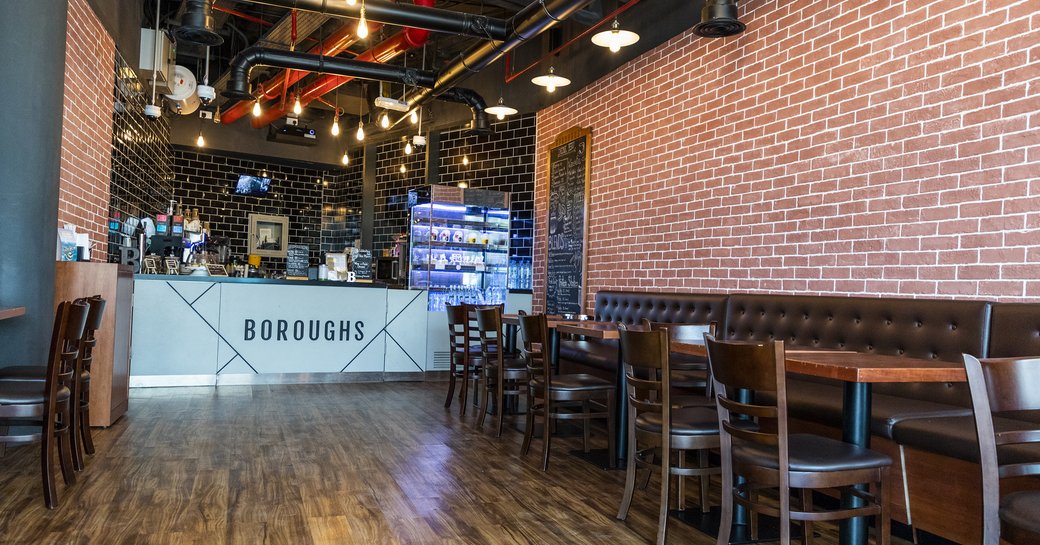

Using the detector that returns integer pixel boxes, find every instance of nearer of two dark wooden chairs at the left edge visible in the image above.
[0,301,88,509]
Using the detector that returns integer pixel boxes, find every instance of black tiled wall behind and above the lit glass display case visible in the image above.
[373,111,535,258]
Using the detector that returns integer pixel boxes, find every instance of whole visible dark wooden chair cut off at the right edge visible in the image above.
[964,354,1040,545]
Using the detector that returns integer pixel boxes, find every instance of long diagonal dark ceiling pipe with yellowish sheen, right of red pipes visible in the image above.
[394,0,592,125]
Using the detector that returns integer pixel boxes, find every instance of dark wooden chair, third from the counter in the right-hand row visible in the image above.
[520,314,616,471]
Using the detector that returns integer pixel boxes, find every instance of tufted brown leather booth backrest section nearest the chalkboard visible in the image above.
[596,291,727,331]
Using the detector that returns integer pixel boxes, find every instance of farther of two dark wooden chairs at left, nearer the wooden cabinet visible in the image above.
[0,295,105,471]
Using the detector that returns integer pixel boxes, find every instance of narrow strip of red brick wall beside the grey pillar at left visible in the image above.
[58,0,115,261]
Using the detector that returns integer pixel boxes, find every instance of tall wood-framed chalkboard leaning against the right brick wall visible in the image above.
[545,128,592,314]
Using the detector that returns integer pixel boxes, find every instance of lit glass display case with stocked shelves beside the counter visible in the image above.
[409,190,510,312]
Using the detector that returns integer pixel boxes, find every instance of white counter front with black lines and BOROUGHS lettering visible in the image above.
[130,276,427,387]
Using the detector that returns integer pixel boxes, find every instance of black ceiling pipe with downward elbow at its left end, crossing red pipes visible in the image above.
[223,46,437,100]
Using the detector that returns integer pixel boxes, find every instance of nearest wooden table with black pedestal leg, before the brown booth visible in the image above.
[671,342,967,545]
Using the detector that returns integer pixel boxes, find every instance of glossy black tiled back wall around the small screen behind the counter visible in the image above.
[174,148,351,271]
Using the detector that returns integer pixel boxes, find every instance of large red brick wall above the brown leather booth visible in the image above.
[535,0,1040,309]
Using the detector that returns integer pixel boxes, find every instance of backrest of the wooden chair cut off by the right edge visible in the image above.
[964,354,1040,545]
